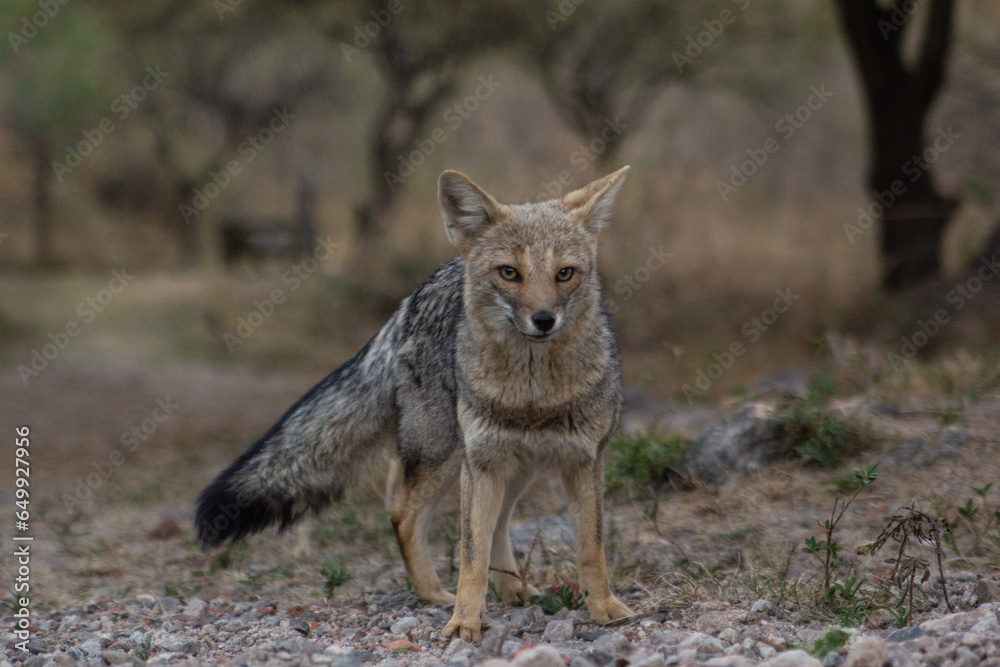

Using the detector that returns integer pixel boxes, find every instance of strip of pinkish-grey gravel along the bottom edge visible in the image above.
[0,573,1000,667]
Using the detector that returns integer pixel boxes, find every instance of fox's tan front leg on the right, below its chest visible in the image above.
[563,455,632,623]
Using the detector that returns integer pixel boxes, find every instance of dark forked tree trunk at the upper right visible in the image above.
[836,0,958,290]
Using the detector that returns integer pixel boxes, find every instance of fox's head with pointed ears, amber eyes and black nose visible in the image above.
[438,167,629,342]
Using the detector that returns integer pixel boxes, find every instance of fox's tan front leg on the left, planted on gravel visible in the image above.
[443,462,504,642]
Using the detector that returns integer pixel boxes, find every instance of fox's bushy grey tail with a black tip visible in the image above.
[195,317,397,547]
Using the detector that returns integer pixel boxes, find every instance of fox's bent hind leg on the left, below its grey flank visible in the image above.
[392,456,459,604]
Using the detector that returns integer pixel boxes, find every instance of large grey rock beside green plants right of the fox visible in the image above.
[688,403,788,484]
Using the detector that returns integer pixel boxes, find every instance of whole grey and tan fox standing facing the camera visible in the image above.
[195,166,632,642]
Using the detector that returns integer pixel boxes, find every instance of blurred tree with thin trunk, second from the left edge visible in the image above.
[110,0,336,265]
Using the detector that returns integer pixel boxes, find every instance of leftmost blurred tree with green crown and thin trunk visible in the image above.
[0,0,118,266]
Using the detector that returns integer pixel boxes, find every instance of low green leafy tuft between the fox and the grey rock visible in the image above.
[604,434,691,491]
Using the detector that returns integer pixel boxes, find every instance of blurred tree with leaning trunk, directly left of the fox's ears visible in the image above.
[327,0,525,242]
